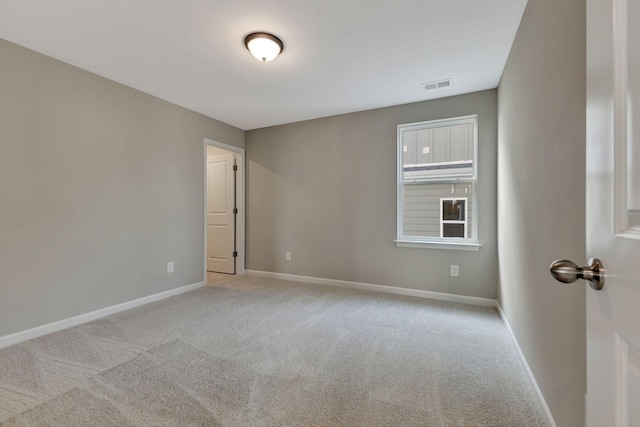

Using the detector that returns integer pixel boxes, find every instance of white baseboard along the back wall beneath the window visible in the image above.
[247,270,498,307]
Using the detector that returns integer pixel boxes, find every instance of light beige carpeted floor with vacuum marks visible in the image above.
[0,276,546,427]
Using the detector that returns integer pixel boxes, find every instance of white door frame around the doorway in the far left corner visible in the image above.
[202,138,245,276]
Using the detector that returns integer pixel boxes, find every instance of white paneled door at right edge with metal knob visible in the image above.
[586,0,640,427]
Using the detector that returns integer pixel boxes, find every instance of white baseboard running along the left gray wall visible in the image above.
[0,282,204,348]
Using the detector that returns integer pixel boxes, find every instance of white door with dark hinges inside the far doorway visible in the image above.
[207,153,235,274]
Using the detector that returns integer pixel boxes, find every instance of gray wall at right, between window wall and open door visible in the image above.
[498,0,586,427]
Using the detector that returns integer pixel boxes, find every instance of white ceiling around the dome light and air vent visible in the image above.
[0,0,526,130]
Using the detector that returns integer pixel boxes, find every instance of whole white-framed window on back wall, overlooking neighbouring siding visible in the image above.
[396,116,480,250]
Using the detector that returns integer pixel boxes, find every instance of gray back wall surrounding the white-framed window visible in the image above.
[246,90,497,298]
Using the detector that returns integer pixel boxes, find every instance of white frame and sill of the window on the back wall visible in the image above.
[394,115,482,251]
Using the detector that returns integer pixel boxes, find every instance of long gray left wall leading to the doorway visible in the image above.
[0,40,244,336]
